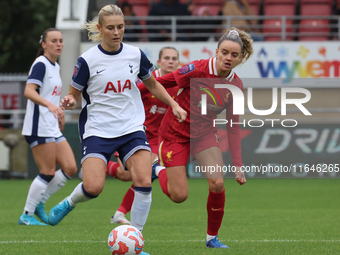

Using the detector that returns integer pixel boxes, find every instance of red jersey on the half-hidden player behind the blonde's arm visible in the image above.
[137,69,178,140]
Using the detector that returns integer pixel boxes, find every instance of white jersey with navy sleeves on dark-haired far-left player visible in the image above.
[22,55,62,138]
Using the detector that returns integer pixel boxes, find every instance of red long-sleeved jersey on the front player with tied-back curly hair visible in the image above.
[157,58,243,166]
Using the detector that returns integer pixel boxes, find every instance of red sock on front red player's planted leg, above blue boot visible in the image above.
[207,189,225,236]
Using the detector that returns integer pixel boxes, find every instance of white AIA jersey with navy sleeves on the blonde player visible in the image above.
[71,43,155,139]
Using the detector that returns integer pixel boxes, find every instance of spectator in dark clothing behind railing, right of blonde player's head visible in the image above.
[147,0,191,41]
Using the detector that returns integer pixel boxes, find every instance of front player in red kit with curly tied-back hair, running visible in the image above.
[151,28,253,248]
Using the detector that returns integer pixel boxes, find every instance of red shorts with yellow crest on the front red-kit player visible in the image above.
[158,133,220,167]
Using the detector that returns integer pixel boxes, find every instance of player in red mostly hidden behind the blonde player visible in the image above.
[106,47,179,224]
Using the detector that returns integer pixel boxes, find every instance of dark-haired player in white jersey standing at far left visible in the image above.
[19,28,77,225]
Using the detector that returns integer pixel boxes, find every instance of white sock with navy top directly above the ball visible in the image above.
[130,187,152,232]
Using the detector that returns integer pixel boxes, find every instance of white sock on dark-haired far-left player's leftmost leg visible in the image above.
[24,175,48,216]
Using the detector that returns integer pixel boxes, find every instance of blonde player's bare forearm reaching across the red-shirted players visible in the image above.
[143,76,187,122]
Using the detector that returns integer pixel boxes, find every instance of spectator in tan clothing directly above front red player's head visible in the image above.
[221,0,264,41]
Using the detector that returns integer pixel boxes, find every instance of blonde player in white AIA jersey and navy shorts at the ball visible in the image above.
[49,5,186,254]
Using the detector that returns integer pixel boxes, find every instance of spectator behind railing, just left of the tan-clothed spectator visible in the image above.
[193,6,221,41]
